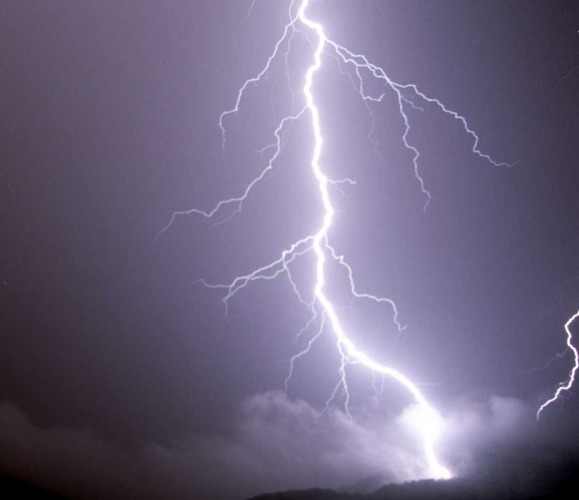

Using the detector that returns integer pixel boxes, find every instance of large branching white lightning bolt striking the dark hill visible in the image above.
[158,0,510,478]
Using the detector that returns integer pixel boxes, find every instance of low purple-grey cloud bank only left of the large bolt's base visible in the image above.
[0,392,404,499]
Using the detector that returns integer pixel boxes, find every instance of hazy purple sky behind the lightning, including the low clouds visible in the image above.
[0,0,579,498]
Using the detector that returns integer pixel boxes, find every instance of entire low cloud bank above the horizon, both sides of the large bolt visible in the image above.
[0,392,569,500]
